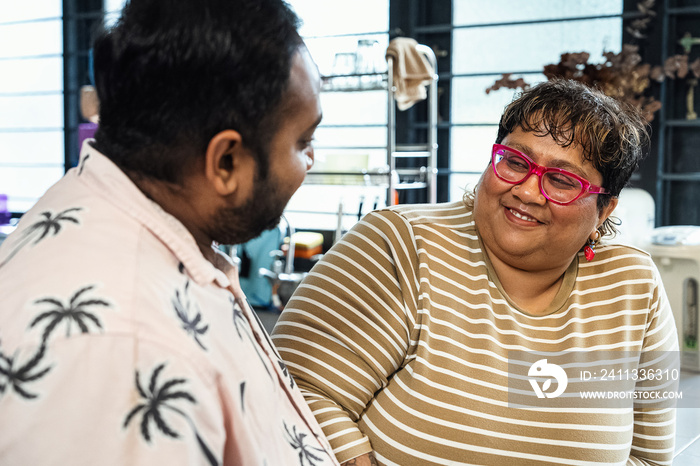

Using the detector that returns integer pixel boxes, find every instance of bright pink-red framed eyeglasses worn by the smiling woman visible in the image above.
[491,144,609,205]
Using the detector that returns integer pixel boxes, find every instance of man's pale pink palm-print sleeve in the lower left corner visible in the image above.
[0,334,226,466]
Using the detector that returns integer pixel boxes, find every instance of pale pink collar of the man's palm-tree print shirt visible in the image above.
[73,139,232,287]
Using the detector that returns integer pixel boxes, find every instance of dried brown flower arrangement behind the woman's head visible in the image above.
[486,0,700,121]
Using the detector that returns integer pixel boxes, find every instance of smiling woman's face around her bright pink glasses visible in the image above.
[474,127,617,271]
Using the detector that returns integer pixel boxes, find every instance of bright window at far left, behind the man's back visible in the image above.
[0,0,64,213]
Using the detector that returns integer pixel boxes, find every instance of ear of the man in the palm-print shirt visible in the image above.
[204,129,255,196]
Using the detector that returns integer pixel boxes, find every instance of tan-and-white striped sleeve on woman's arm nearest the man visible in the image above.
[272,211,418,463]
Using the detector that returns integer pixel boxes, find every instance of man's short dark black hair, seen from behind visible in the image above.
[94,0,303,184]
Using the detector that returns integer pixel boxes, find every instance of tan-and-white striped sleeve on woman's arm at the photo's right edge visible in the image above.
[627,260,680,465]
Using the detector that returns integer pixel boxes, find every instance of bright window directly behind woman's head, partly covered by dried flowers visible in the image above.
[448,0,623,200]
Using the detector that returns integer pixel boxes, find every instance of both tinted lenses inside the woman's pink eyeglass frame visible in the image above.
[494,149,583,202]
